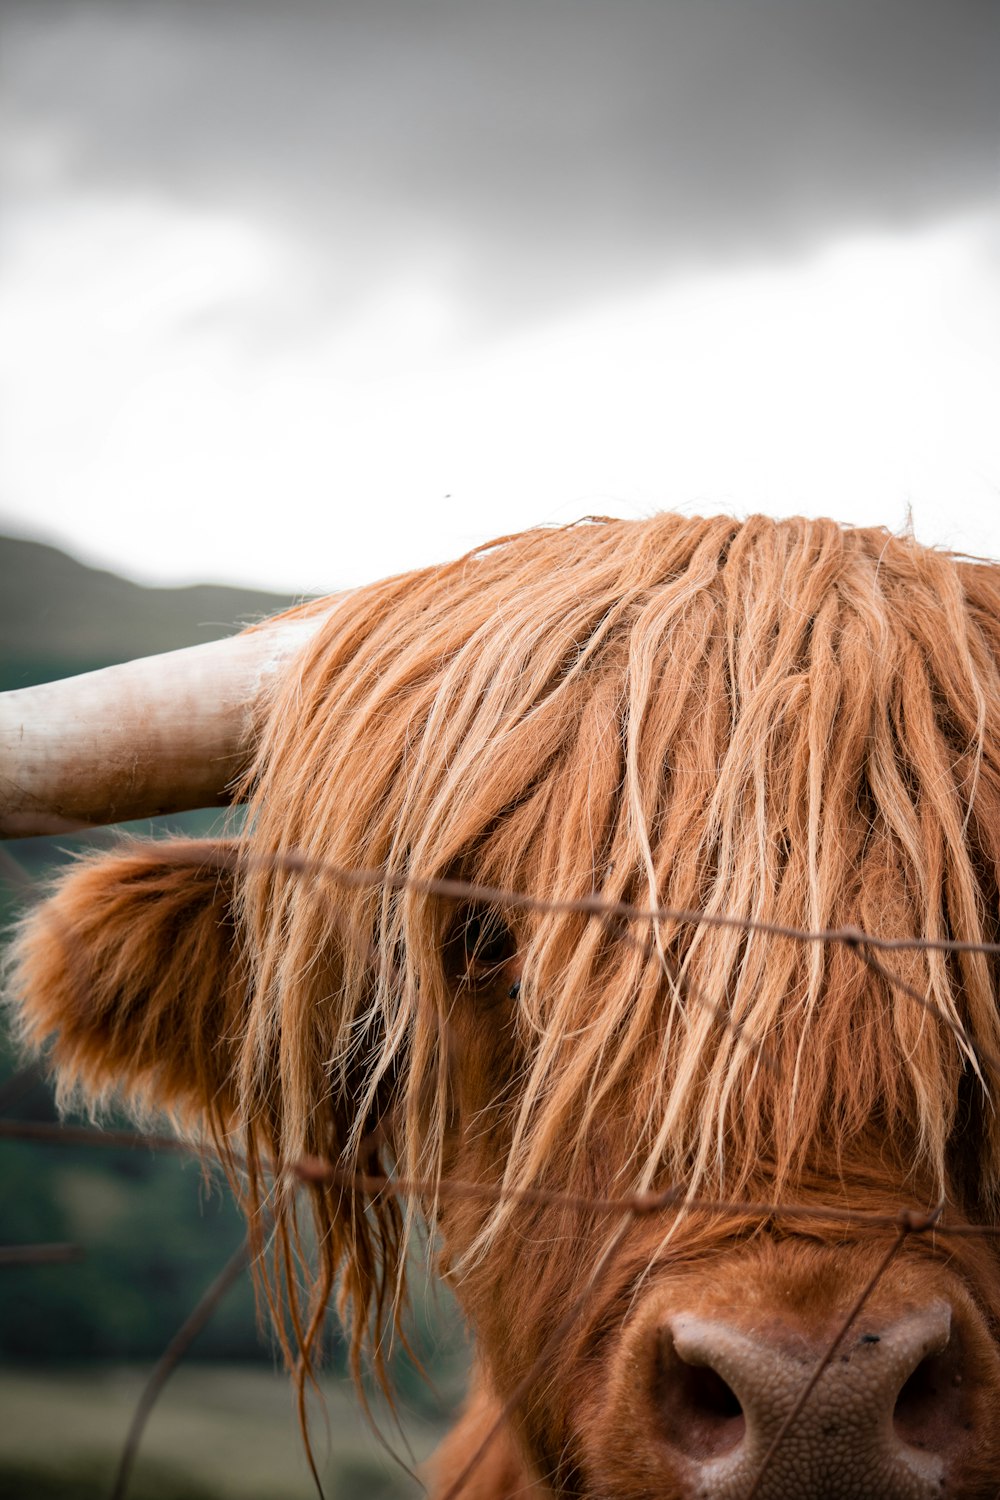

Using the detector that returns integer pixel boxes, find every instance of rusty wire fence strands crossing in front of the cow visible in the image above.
[0,825,1000,1500]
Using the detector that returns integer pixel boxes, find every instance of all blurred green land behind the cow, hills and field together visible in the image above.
[0,537,465,1482]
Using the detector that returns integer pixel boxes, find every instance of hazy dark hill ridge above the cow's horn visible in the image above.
[0,537,307,689]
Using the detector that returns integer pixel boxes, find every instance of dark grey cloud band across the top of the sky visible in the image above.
[0,0,1000,315]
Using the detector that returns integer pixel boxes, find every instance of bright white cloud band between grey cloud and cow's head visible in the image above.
[0,200,1000,590]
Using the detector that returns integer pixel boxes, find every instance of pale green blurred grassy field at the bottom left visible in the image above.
[0,1365,461,1500]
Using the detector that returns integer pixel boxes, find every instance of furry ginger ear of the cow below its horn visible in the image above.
[7,842,246,1131]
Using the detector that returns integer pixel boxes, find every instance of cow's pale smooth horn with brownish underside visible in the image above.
[0,614,325,839]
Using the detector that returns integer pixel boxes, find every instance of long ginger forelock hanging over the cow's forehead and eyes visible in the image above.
[243,516,1000,1254]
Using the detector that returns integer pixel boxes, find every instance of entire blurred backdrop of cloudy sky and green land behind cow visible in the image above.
[0,0,1000,1500]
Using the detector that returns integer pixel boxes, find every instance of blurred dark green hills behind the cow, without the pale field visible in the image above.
[0,537,305,1374]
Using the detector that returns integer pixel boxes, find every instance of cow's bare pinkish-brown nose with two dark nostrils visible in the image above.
[655,1301,970,1500]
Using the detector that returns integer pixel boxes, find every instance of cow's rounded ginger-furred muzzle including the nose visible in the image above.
[577,1242,1000,1500]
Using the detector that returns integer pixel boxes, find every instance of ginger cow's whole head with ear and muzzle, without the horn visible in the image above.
[5,516,1000,1500]
